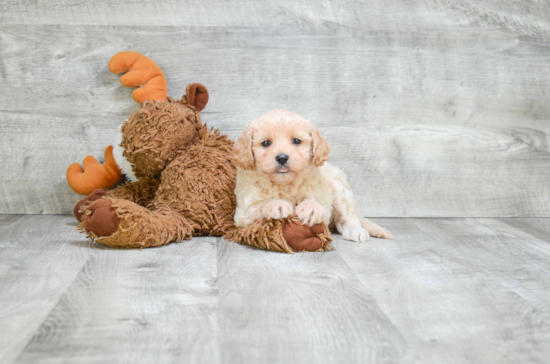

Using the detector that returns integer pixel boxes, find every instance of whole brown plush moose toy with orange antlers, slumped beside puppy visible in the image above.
[67,52,332,253]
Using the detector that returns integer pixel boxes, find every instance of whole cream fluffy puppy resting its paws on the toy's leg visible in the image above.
[234,110,392,241]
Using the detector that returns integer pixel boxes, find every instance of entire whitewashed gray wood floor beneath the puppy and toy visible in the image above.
[0,215,550,363]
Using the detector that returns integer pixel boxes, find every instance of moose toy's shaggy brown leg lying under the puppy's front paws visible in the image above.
[224,218,332,253]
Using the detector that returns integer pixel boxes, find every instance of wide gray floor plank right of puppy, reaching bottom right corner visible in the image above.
[334,219,550,363]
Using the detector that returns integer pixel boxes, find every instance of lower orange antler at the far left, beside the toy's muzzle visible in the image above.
[67,145,122,195]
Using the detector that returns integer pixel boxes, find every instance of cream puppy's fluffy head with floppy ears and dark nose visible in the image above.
[234,110,329,183]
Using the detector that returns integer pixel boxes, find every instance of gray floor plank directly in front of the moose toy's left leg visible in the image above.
[16,238,220,363]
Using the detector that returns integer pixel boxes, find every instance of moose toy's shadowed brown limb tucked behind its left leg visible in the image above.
[74,180,159,222]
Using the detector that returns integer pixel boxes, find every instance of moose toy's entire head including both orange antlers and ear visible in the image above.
[67,51,208,195]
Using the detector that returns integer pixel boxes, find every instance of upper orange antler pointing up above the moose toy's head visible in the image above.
[109,51,168,104]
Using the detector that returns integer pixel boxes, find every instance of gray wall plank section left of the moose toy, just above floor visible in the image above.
[0,112,122,214]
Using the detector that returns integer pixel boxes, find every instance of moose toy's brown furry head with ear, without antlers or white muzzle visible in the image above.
[120,83,208,179]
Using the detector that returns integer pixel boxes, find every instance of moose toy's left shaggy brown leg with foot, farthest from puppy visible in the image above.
[79,197,195,248]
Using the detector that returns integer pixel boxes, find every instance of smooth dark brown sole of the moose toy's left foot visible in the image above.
[85,198,120,237]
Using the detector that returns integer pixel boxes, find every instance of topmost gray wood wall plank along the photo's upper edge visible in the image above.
[0,0,550,35]
